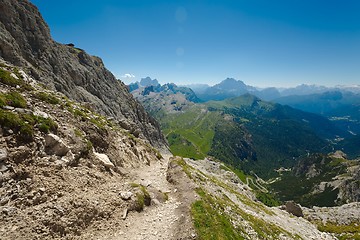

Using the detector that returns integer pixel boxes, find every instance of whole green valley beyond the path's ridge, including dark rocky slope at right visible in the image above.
[132,79,359,207]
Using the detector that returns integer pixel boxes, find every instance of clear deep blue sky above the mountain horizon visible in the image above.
[31,0,360,87]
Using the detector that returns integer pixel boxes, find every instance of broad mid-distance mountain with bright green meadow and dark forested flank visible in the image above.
[133,85,348,176]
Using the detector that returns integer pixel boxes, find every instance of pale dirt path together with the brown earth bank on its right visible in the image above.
[74,155,196,240]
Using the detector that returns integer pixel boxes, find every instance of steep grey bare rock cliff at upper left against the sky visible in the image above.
[0,0,167,149]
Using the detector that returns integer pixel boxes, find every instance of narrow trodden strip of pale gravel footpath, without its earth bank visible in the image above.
[114,156,180,240]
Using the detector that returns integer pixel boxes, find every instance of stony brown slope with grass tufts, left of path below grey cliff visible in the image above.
[0,62,171,239]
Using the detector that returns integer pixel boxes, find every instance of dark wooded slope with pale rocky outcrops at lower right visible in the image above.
[269,151,360,206]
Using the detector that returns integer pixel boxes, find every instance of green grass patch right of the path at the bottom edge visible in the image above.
[191,188,301,239]
